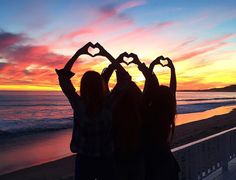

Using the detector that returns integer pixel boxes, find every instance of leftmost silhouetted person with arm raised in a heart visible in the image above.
[56,42,114,180]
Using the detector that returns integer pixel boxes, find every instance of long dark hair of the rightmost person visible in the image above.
[144,86,176,142]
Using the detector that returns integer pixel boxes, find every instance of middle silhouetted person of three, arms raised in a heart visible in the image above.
[93,44,144,180]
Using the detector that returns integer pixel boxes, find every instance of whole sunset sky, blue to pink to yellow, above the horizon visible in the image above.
[0,0,236,90]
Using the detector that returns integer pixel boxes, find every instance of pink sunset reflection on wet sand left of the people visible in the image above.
[0,129,71,174]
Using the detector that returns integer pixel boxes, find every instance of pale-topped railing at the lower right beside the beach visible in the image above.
[172,127,236,180]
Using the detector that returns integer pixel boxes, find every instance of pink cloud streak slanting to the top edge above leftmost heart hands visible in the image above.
[49,1,145,49]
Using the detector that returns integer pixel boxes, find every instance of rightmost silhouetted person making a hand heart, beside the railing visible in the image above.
[128,54,180,180]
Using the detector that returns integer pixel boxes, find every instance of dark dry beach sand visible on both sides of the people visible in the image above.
[0,109,236,180]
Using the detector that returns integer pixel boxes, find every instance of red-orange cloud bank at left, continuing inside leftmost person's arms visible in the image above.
[0,29,114,86]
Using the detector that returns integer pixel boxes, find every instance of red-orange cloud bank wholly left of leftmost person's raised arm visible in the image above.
[0,32,69,85]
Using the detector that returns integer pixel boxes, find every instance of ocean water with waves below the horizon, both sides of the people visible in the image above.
[0,91,236,136]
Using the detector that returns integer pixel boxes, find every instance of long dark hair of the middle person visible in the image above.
[112,82,142,153]
